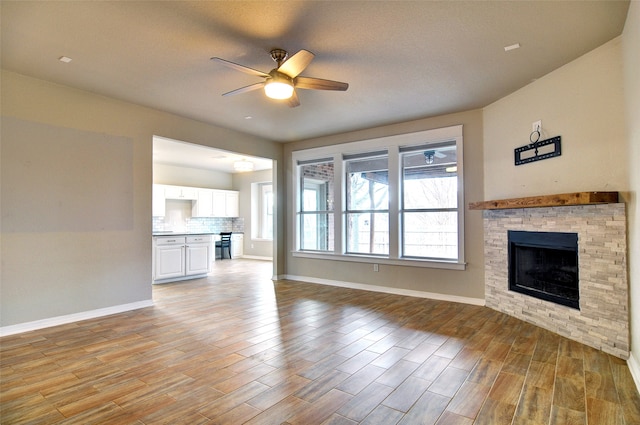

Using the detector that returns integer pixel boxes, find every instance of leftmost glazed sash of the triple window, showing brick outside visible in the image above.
[298,161,334,251]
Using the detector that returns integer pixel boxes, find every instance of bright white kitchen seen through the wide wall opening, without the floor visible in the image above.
[152,136,273,284]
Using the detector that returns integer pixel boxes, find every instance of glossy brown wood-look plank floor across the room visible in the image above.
[0,259,640,425]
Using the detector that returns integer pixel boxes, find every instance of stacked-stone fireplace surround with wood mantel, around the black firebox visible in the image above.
[469,192,630,359]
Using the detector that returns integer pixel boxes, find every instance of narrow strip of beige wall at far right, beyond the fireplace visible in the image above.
[622,1,640,376]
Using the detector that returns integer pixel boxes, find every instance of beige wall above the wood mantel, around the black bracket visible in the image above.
[484,38,629,200]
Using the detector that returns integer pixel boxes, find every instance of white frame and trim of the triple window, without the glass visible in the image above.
[290,125,466,270]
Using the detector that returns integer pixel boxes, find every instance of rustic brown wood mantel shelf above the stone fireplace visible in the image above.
[469,192,618,210]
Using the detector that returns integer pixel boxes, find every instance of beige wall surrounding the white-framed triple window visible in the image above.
[284,110,484,300]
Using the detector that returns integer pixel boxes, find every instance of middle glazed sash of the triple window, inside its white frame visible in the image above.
[344,153,389,255]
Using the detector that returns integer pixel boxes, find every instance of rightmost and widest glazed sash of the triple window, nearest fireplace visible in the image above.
[400,141,458,260]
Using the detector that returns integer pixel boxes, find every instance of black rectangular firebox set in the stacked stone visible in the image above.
[507,230,580,309]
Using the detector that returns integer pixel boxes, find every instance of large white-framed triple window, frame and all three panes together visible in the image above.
[292,126,465,270]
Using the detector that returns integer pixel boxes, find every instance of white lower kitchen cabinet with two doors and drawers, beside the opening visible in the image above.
[153,235,212,283]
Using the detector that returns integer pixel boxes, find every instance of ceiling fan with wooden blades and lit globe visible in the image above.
[211,49,349,108]
